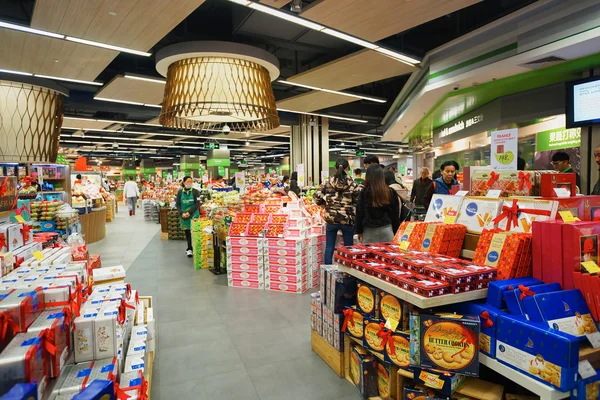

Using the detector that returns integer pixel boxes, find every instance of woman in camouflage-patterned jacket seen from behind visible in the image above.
[313,158,360,265]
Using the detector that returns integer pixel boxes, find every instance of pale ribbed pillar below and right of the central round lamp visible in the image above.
[290,115,328,185]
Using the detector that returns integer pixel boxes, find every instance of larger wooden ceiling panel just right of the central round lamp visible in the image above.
[287,50,417,90]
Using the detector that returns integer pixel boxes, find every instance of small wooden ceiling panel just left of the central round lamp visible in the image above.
[96,75,165,104]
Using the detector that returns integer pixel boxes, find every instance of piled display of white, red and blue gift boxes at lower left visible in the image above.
[0,228,158,399]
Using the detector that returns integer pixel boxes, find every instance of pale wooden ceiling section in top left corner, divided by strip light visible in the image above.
[0,0,205,80]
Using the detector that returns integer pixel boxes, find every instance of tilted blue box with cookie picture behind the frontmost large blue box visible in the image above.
[523,289,597,340]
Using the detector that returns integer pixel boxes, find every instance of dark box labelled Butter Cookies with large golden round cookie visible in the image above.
[410,314,480,376]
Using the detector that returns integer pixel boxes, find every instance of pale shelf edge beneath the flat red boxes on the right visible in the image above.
[338,265,487,308]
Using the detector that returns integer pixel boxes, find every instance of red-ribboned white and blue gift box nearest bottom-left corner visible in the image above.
[0,332,49,393]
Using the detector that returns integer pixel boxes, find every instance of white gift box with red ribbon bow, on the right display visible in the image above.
[494,198,558,233]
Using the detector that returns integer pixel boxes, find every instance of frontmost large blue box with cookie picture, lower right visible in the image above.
[496,314,579,392]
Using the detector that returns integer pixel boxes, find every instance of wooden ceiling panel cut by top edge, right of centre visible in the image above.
[301,0,481,41]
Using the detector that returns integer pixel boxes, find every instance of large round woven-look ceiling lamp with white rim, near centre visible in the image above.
[156,41,279,131]
